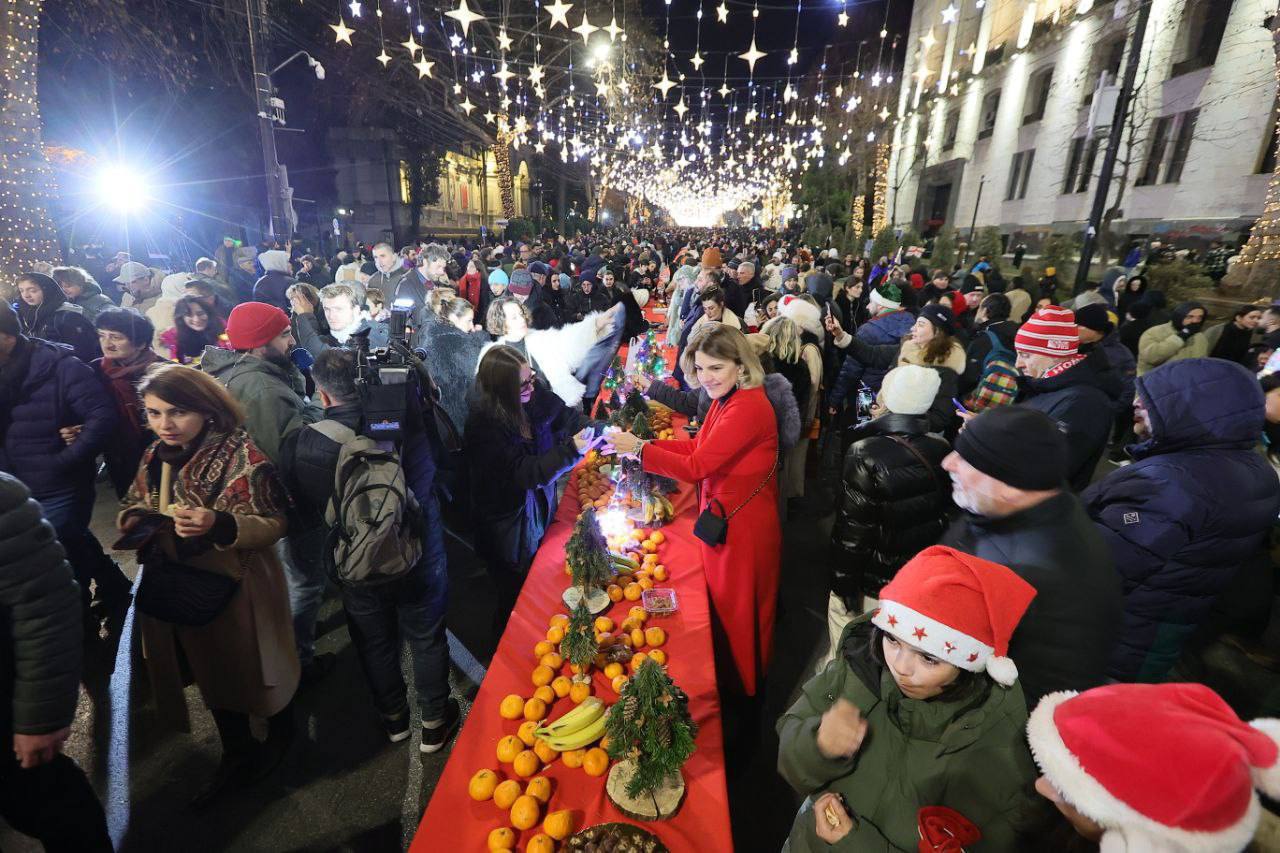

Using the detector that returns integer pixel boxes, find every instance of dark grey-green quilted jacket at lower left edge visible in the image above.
[0,474,83,735]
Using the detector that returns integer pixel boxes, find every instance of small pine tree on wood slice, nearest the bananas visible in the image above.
[604,660,698,797]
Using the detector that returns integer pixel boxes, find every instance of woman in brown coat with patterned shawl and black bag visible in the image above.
[116,364,300,807]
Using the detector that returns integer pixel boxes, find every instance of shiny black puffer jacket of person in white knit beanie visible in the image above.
[831,414,954,604]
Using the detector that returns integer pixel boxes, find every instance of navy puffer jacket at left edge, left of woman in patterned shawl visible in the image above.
[0,337,116,500]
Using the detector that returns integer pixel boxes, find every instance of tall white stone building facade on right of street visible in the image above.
[888,0,1276,251]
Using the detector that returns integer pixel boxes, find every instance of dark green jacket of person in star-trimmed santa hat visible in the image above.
[777,616,1042,853]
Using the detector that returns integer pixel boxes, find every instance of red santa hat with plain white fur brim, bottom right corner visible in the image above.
[1027,684,1280,853]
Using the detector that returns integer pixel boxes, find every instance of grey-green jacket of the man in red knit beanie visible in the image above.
[200,347,324,462]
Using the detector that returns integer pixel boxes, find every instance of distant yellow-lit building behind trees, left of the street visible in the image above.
[328,127,538,245]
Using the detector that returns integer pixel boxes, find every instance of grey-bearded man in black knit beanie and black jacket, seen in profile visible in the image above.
[941,406,1123,708]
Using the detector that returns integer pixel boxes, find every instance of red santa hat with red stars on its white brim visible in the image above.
[872,546,1036,686]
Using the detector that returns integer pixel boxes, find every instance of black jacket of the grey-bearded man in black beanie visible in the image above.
[942,491,1123,710]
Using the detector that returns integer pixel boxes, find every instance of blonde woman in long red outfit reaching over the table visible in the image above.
[612,324,782,695]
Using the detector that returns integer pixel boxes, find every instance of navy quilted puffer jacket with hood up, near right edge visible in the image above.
[1082,359,1280,681]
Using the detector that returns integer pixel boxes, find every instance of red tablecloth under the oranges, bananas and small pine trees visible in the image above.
[410,295,733,853]
